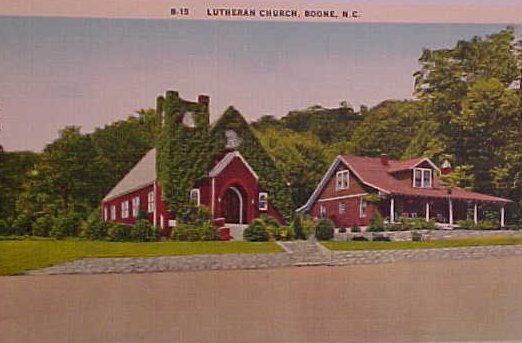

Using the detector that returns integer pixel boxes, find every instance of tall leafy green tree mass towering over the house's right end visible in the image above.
[415,27,522,202]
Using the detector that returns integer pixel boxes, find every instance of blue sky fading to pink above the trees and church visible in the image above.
[0,16,504,150]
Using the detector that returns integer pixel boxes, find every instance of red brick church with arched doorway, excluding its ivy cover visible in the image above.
[101,93,284,239]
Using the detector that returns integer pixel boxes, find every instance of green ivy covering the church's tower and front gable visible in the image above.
[156,91,293,219]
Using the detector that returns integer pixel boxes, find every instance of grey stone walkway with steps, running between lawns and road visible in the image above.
[26,240,522,275]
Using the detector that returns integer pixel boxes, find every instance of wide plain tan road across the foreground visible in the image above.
[0,257,522,342]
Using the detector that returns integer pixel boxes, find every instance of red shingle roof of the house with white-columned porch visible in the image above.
[339,155,511,202]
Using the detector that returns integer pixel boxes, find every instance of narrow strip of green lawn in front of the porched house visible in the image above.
[321,236,522,250]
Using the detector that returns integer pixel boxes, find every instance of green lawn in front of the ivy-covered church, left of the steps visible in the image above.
[0,239,282,275]
